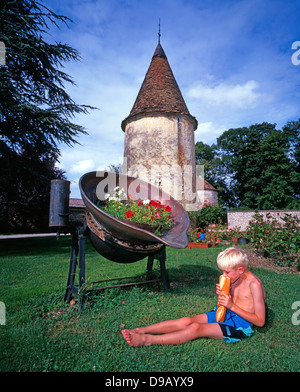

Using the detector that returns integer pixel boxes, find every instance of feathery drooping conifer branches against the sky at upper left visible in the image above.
[0,0,92,153]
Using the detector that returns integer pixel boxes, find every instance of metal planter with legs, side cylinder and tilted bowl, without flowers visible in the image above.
[49,172,190,308]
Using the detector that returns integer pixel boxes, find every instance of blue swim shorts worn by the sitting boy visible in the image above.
[206,306,254,343]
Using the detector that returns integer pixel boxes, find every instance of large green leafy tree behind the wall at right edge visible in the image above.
[217,121,300,209]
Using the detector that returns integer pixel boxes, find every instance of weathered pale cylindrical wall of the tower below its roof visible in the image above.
[124,114,196,206]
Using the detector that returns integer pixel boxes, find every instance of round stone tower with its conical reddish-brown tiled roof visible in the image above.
[121,42,198,207]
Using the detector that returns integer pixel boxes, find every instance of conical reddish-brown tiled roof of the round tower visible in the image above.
[122,43,196,131]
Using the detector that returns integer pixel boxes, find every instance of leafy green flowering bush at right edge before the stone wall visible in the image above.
[247,213,300,268]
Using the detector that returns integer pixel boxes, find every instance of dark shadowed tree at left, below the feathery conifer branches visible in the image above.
[0,146,64,232]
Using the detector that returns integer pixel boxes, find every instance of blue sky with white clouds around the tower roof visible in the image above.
[43,0,300,197]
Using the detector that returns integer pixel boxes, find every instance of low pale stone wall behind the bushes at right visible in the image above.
[227,210,300,230]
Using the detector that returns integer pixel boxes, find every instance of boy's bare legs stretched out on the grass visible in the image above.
[122,322,223,347]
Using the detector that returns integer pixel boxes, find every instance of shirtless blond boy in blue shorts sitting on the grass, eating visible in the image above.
[121,248,266,347]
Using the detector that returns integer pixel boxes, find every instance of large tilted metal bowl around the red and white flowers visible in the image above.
[79,171,190,262]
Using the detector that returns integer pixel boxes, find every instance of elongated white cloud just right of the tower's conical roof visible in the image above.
[187,80,261,109]
